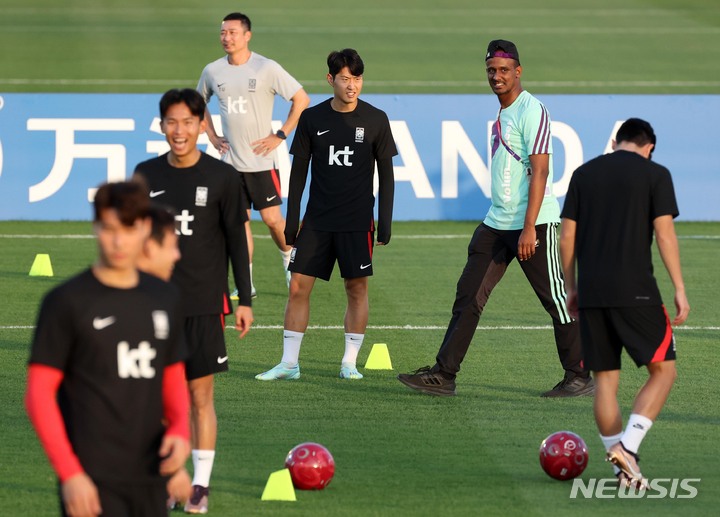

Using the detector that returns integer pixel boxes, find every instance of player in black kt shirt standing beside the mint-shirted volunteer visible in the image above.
[255,49,397,381]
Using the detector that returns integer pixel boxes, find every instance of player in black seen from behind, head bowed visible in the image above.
[560,118,690,488]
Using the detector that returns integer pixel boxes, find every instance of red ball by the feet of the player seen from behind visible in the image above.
[540,431,588,481]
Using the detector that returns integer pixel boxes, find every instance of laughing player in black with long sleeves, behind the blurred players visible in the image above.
[135,88,253,513]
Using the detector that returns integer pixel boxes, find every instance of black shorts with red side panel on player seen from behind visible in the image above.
[579,305,675,371]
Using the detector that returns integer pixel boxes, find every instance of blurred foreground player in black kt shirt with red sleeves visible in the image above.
[26,182,190,517]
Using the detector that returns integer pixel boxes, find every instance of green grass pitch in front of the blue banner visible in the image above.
[0,222,720,517]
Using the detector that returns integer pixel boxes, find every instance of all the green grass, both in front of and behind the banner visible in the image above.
[0,0,720,517]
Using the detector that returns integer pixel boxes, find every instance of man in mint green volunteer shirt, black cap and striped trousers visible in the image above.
[398,40,595,397]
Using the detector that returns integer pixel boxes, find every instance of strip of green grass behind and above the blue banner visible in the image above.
[0,0,720,94]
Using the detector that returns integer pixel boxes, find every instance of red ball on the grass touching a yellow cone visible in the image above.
[285,442,335,490]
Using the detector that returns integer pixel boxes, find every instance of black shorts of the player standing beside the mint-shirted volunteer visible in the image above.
[288,228,375,280]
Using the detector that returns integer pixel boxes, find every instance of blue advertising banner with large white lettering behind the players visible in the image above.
[0,94,720,221]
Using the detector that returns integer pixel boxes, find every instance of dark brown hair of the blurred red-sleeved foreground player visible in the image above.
[93,178,150,226]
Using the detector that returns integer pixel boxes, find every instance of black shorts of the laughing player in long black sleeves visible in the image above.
[185,314,228,381]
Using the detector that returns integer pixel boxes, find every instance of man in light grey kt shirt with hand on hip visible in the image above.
[197,13,310,299]
